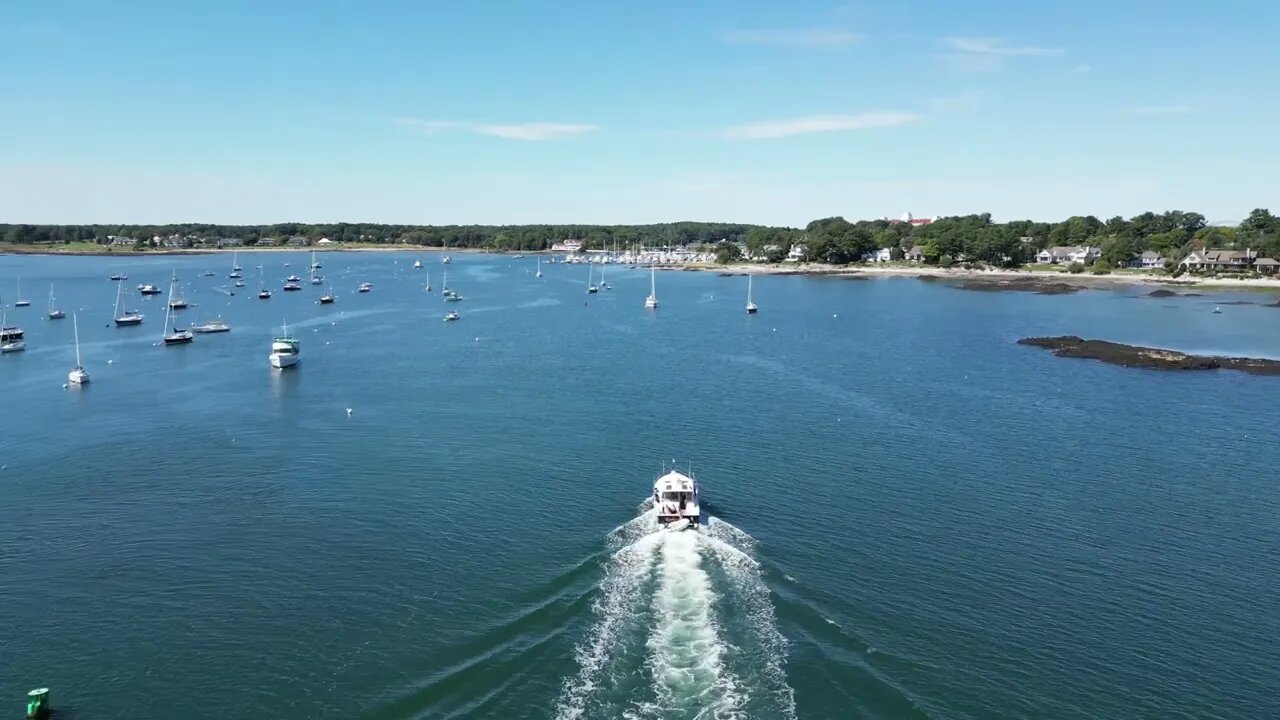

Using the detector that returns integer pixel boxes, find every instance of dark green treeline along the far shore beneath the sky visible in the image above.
[0,209,1280,265]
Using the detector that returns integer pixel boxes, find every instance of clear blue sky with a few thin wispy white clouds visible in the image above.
[0,0,1280,225]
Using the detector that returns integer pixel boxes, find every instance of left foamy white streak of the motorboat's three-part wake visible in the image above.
[556,530,663,720]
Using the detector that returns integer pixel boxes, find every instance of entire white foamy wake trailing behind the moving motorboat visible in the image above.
[556,510,795,720]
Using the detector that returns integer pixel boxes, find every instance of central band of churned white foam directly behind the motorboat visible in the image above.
[648,532,744,719]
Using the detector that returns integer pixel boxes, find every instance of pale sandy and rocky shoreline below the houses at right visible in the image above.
[666,263,1280,292]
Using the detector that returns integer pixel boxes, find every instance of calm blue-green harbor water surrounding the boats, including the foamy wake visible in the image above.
[0,252,1280,719]
